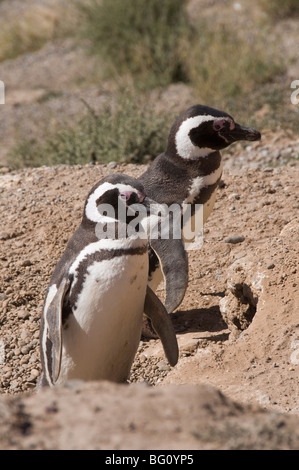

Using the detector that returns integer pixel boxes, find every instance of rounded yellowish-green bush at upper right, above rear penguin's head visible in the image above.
[189,22,284,102]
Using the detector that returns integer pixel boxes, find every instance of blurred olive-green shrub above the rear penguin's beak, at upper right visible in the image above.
[184,21,285,122]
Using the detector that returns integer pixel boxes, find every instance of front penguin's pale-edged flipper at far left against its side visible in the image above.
[44,277,71,385]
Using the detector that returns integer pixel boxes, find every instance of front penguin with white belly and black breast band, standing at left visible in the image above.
[40,174,178,386]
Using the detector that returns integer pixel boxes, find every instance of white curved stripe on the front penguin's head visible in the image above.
[85,181,139,223]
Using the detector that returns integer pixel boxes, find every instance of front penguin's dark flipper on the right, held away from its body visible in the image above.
[144,286,179,367]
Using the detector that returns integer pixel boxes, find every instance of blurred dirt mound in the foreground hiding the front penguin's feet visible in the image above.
[0,382,299,450]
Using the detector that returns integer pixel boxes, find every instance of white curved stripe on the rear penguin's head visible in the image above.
[175,114,234,160]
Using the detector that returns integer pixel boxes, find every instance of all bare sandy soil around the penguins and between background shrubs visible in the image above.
[0,0,299,450]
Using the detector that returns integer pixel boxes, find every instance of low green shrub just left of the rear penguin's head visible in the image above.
[9,91,173,168]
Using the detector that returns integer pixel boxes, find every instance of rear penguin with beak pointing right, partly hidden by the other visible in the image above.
[138,105,261,312]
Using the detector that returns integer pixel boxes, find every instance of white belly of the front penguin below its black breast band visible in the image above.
[58,252,148,383]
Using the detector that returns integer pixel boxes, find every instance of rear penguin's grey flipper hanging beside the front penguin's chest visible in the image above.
[150,239,188,313]
